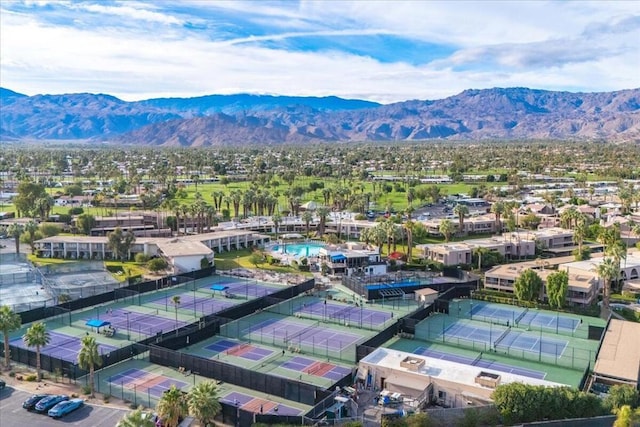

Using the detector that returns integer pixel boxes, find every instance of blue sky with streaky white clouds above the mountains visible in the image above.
[0,0,640,103]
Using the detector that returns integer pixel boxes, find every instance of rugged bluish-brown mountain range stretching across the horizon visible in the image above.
[0,88,640,147]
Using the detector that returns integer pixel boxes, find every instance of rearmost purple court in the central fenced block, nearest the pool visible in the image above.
[295,300,393,326]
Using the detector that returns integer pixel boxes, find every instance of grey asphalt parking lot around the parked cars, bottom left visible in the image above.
[0,387,127,427]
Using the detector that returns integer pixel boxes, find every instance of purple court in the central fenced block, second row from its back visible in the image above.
[241,318,362,351]
